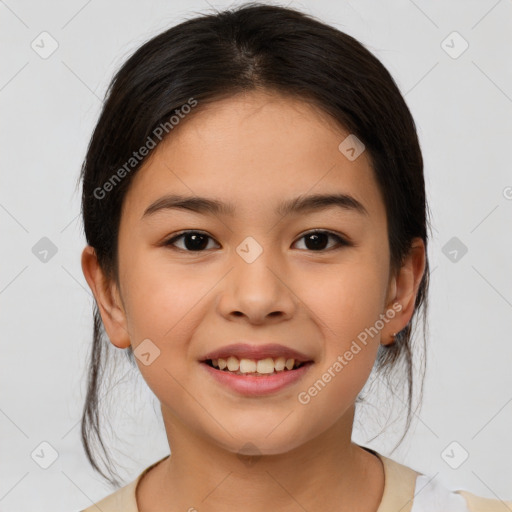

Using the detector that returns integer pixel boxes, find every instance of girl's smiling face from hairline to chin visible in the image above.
[87,88,407,454]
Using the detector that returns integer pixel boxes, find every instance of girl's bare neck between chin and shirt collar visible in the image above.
[137,408,384,512]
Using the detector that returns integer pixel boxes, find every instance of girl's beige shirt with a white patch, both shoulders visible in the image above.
[80,447,512,512]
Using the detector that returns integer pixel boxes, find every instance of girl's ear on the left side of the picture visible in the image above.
[82,245,130,348]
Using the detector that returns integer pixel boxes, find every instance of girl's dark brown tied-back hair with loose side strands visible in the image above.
[80,3,429,486]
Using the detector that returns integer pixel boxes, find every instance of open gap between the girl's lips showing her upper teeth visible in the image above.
[202,356,313,377]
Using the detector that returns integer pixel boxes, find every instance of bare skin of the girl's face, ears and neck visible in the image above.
[82,91,425,512]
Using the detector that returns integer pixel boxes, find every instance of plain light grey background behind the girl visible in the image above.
[0,0,512,512]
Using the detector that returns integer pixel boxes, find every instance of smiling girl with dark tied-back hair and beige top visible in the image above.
[81,4,512,512]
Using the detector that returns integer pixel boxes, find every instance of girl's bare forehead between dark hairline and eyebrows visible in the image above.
[120,91,384,218]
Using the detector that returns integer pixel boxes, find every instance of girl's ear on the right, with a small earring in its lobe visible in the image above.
[381,238,426,345]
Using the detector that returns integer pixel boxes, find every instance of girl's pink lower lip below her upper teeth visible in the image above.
[201,362,313,396]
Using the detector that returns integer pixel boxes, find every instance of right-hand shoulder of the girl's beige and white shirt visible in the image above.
[375,452,512,512]
